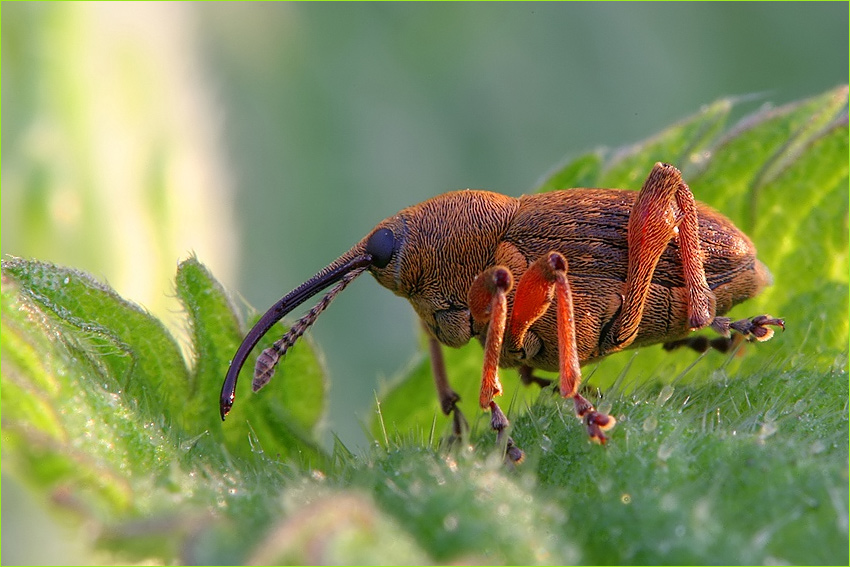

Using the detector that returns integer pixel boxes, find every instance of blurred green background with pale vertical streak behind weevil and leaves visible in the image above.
[2,2,848,563]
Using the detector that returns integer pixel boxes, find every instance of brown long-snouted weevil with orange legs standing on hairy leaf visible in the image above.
[220,163,785,462]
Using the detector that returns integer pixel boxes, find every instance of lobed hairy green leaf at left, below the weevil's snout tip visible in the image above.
[2,258,326,561]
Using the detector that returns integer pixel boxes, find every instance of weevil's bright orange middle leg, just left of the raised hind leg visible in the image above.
[510,252,616,443]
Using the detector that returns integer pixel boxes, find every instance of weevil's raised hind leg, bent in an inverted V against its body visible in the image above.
[602,163,715,352]
